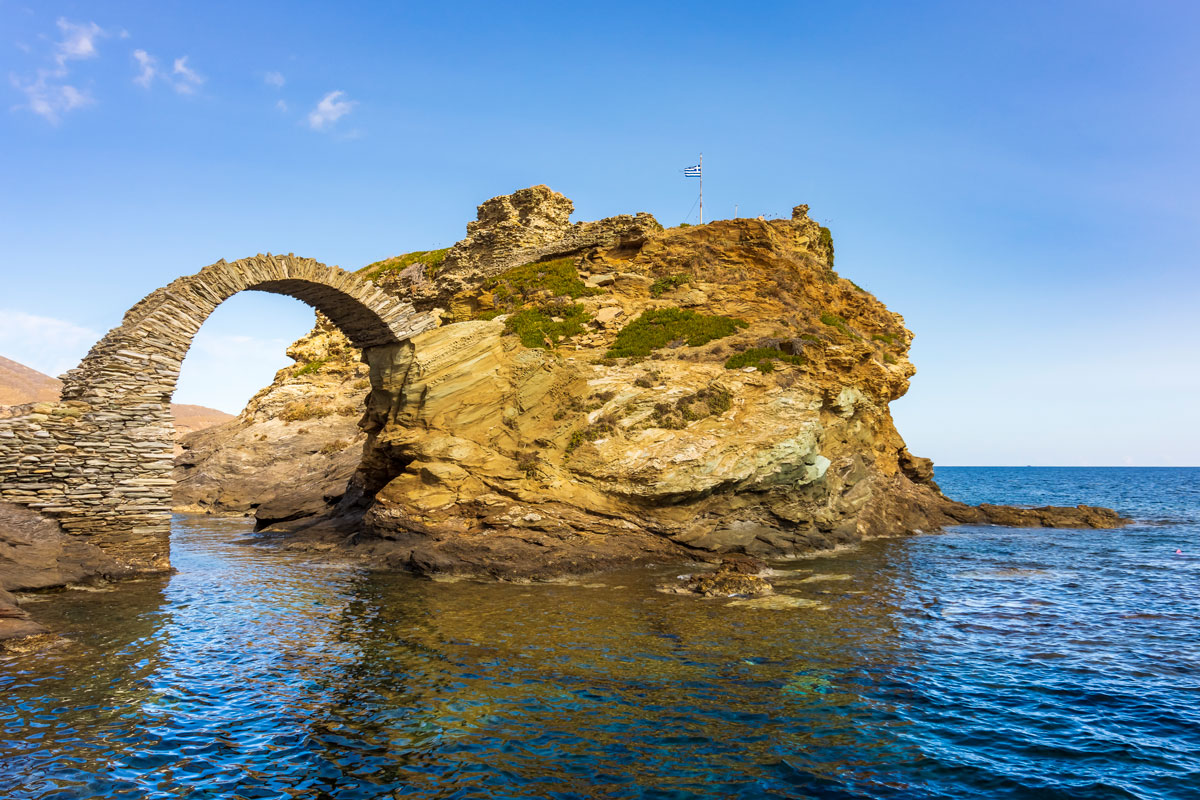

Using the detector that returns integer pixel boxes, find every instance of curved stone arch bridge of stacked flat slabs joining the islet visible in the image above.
[0,254,437,571]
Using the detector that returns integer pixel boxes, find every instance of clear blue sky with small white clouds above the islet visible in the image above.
[0,0,1200,464]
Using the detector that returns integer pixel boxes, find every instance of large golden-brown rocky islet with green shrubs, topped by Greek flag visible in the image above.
[194,187,1124,578]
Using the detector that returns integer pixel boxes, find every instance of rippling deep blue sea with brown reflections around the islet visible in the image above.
[0,468,1200,800]
